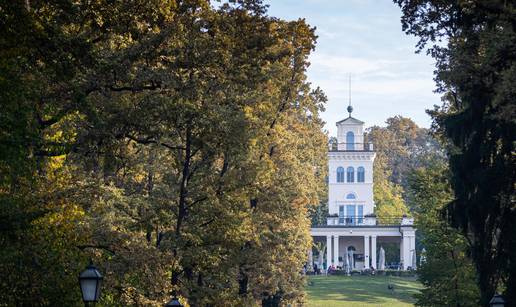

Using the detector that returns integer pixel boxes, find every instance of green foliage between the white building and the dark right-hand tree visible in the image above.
[409,161,480,306]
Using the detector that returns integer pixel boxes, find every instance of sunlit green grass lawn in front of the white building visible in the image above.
[306,276,421,307]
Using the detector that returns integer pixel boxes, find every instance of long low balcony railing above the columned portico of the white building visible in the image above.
[326,216,414,226]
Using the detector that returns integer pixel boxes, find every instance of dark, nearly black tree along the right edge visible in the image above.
[395,0,516,306]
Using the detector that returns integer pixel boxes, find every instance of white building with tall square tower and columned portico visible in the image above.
[308,106,416,270]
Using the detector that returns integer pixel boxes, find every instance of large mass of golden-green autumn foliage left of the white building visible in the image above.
[0,0,327,306]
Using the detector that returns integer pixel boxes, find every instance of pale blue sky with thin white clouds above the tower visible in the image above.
[266,0,441,135]
